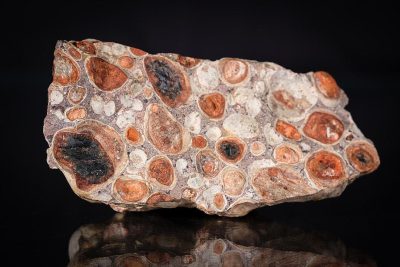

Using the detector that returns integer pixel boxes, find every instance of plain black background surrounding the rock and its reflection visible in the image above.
[0,1,400,266]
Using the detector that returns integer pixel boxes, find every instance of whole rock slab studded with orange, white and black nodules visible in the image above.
[44,40,379,216]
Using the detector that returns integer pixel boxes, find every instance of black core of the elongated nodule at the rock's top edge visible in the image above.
[148,60,182,99]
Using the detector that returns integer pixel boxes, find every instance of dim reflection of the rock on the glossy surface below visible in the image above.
[69,213,376,267]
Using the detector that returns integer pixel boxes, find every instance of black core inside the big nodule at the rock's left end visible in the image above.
[61,134,112,184]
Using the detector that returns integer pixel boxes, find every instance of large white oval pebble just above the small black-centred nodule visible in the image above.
[223,113,259,138]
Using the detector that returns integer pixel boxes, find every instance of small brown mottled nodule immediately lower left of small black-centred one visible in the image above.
[196,149,222,177]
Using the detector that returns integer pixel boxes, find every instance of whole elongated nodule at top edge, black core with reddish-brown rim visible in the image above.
[144,56,191,108]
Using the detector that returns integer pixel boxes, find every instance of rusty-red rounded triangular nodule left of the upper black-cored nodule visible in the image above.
[86,57,128,91]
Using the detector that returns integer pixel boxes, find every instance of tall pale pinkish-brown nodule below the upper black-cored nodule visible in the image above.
[146,104,186,154]
